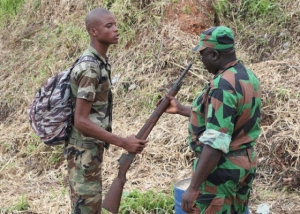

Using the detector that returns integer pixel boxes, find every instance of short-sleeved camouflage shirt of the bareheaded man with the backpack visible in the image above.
[70,46,112,141]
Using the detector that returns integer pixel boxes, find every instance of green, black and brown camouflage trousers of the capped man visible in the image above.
[193,149,257,214]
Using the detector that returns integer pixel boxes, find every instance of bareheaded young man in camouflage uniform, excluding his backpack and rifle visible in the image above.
[65,8,146,214]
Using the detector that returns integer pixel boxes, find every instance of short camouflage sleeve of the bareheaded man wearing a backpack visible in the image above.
[75,62,99,102]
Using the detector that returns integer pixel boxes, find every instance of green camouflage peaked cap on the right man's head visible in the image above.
[192,26,234,52]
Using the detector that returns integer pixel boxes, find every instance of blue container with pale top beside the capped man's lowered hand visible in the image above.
[174,178,250,214]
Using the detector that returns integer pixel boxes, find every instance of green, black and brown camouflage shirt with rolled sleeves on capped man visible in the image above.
[188,60,261,153]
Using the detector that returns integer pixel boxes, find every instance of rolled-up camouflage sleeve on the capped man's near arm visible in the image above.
[199,89,237,153]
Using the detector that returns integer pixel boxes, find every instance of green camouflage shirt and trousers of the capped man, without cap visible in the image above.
[188,61,261,214]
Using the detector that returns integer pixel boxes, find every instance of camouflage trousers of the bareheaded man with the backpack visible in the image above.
[65,141,104,214]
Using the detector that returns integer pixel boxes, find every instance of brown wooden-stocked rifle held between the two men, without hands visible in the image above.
[102,63,192,214]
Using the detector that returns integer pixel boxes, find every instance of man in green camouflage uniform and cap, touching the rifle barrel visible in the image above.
[166,26,261,214]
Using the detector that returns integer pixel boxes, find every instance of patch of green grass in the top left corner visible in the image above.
[0,0,24,26]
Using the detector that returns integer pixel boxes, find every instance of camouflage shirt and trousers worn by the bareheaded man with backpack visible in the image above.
[65,46,112,214]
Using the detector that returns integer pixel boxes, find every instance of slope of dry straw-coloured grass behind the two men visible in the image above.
[0,0,300,213]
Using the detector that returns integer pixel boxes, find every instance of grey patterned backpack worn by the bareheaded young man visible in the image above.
[28,55,99,146]
